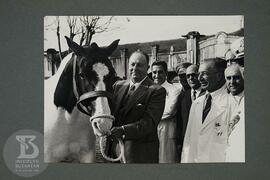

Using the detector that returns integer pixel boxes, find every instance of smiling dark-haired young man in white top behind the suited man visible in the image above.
[151,61,180,163]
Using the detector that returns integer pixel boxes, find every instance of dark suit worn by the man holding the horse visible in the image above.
[110,78,166,163]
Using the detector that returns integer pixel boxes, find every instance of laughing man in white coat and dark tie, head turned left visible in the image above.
[181,58,228,163]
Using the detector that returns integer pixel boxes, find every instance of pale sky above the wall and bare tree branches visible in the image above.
[44,15,244,51]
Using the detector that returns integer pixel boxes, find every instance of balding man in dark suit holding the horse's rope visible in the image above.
[108,51,166,163]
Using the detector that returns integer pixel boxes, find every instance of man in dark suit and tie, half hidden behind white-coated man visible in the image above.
[177,64,205,153]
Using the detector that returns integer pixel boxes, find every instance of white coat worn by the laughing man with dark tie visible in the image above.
[181,86,228,163]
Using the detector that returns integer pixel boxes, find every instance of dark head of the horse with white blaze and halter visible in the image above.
[54,37,119,135]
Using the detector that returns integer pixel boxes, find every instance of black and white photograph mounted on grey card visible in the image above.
[43,14,246,164]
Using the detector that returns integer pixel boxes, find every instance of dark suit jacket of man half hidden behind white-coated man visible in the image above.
[176,89,205,147]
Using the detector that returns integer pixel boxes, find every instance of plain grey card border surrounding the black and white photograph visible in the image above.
[0,0,270,180]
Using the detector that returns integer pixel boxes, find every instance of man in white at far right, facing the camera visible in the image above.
[225,64,245,162]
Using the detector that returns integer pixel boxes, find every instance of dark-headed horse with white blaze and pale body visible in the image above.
[44,37,120,163]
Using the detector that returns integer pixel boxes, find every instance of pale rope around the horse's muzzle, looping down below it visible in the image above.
[90,114,126,163]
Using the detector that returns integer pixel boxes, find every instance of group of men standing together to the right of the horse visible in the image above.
[108,47,245,163]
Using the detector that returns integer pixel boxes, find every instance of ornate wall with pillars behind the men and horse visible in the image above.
[44,28,244,79]
